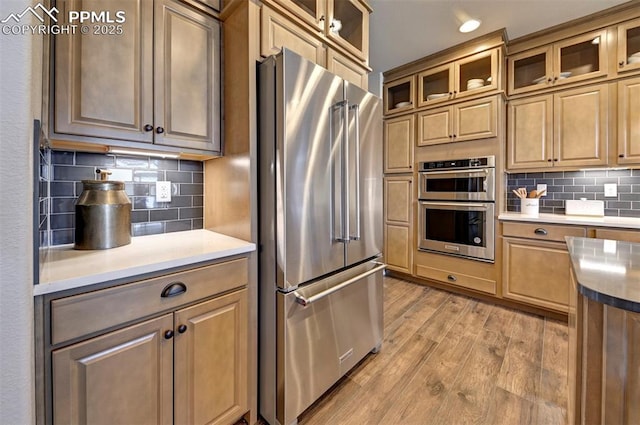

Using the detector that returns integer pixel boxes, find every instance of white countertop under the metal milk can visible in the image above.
[33,229,256,296]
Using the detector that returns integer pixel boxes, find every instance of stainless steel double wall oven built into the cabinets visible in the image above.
[418,156,496,262]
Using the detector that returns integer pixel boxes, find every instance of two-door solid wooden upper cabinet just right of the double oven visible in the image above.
[507,84,609,169]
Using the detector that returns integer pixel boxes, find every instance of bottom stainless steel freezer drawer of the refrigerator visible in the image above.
[277,262,384,424]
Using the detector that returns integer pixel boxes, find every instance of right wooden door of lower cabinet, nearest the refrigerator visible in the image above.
[174,289,248,425]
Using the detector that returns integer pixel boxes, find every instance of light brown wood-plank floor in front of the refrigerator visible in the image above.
[299,277,568,425]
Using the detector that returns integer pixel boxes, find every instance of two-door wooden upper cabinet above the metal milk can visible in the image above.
[53,0,221,152]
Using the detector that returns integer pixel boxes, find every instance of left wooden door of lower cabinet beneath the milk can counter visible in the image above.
[52,314,173,425]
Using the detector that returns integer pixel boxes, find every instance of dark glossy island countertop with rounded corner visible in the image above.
[566,237,640,313]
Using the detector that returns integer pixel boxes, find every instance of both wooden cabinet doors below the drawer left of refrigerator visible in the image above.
[52,289,248,425]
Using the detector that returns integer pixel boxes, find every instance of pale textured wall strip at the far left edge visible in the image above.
[0,0,41,425]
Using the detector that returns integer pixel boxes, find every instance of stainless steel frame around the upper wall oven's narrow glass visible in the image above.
[418,168,496,201]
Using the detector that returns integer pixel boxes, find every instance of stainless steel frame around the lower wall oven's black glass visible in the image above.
[418,201,495,262]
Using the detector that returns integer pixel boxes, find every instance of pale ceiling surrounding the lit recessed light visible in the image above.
[369,0,640,72]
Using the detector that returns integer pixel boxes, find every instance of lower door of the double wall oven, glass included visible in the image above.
[418,201,495,262]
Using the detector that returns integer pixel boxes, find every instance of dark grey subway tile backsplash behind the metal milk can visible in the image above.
[48,151,204,245]
